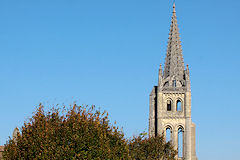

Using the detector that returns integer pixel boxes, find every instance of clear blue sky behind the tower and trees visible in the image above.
[0,0,240,160]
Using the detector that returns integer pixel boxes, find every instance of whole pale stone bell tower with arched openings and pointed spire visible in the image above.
[149,4,197,160]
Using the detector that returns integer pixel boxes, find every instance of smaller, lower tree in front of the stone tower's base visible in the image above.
[129,133,177,160]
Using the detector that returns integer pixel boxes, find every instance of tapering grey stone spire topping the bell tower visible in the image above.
[164,3,184,80]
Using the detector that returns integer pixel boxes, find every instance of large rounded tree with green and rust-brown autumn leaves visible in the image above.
[3,104,130,160]
